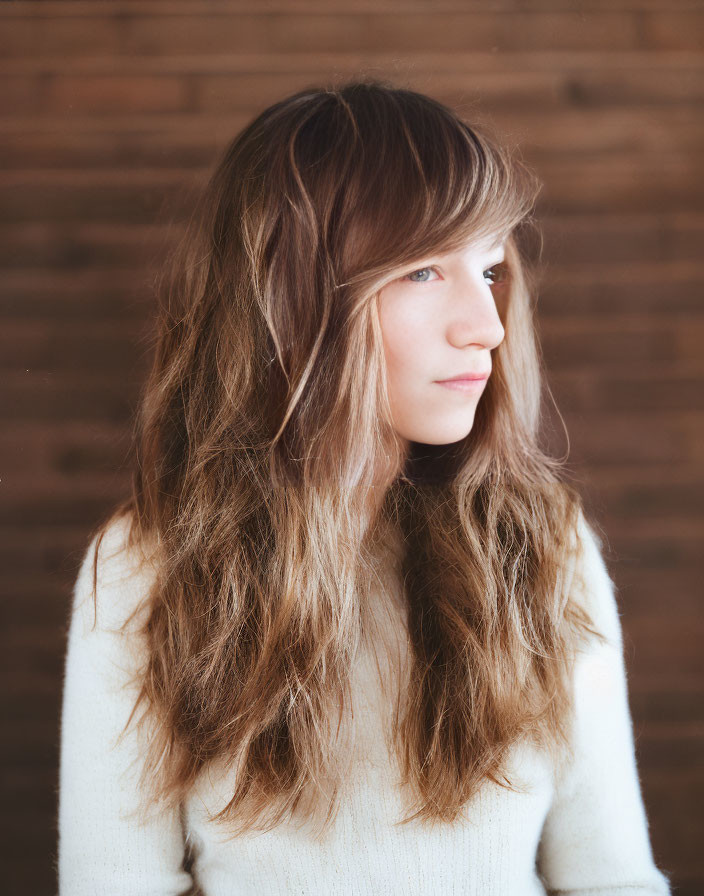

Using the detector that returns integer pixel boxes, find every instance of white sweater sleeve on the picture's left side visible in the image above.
[58,522,193,896]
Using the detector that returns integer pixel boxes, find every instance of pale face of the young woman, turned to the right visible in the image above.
[379,238,504,445]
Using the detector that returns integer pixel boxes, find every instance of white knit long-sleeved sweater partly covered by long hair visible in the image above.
[58,521,670,896]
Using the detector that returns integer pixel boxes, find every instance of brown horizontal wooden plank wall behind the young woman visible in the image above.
[0,0,704,896]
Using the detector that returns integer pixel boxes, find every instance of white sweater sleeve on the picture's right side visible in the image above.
[538,515,670,896]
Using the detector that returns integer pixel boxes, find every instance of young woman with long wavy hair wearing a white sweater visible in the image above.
[58,79,669,896]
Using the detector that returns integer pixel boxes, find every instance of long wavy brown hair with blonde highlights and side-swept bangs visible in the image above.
[85,78,599,833]
